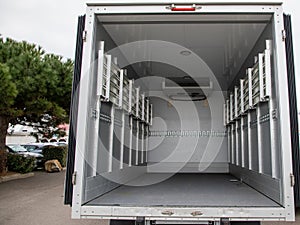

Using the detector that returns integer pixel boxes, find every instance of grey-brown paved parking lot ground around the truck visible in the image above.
[0,171,300,225]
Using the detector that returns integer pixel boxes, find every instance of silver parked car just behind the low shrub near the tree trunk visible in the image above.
[6,144,44,168]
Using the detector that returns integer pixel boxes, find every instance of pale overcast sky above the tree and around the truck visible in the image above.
[0,0,300,93]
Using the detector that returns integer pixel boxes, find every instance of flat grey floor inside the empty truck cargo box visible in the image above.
[87,174,279,207]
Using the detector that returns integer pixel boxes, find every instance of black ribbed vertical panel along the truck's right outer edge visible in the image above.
[284,15,300,207]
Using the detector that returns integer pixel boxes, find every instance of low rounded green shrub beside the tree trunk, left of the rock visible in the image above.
[7,154,36,173]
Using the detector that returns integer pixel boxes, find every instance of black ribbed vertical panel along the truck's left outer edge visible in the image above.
[64,15,85,205]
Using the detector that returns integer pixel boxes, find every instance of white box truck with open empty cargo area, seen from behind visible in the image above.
[65,0,300,224]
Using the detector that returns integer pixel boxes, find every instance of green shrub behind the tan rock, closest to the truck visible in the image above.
[43,145,68,167]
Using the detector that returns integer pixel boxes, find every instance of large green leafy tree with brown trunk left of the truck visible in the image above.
[0,39,73,173]
